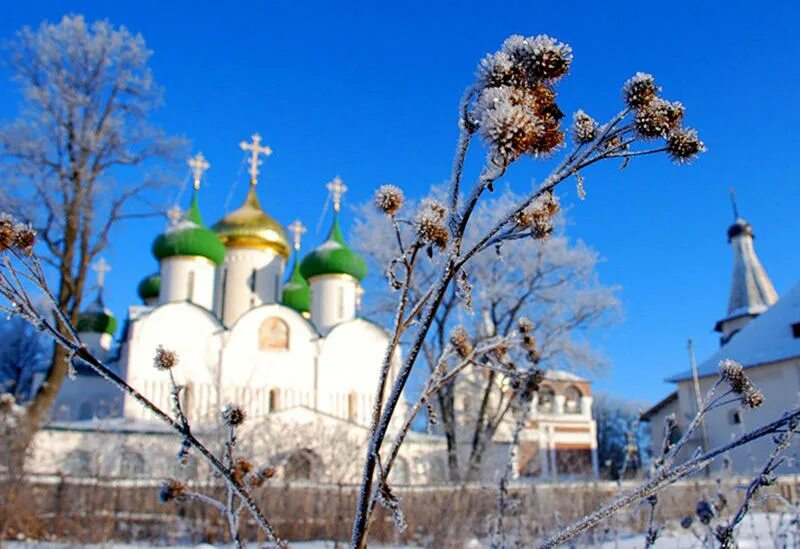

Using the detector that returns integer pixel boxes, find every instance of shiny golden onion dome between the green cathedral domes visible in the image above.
[211,184,291,258]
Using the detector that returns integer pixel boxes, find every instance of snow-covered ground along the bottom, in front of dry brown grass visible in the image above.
[2,513,800,549]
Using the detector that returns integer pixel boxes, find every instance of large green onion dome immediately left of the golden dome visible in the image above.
[153,191,225,265]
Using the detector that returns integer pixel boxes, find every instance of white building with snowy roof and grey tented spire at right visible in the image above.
[644,204,800,474]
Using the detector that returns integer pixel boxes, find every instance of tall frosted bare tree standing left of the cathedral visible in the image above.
[0,15,182,444]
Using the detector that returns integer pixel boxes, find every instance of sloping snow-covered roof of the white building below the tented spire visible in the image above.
[668,284,800,382]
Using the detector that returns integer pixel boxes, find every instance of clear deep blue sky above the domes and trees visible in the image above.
[0,1,800,402]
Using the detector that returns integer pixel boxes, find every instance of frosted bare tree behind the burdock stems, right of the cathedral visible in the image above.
[354,189,619,481]
